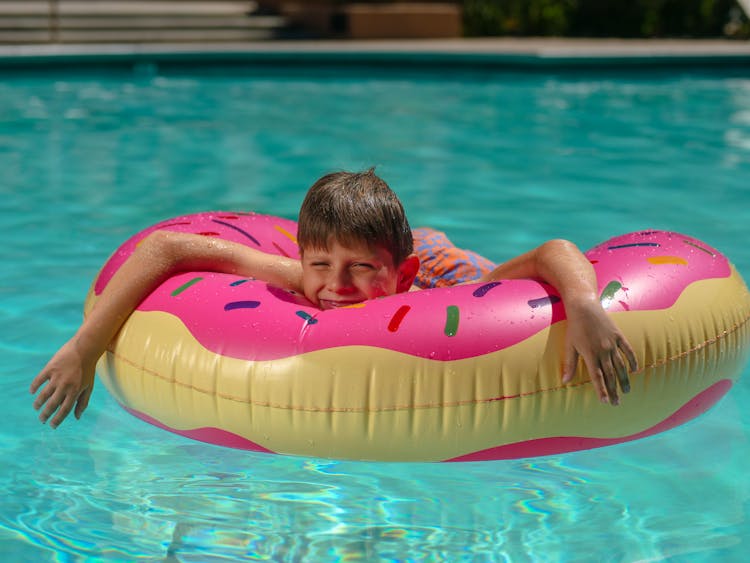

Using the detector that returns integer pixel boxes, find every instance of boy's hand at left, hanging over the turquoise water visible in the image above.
[29,340,96,428]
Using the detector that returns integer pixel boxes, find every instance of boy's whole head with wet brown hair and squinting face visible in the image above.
[297,169,419,309]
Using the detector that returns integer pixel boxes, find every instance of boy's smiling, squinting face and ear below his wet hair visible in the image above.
[302,239,419,309]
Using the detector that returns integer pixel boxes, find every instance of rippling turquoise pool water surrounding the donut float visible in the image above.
[0,59,750,562]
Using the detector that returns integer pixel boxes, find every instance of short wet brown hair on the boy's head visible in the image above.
[297,168,414,265]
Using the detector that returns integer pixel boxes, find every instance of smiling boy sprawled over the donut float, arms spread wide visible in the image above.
[30,169,637,428]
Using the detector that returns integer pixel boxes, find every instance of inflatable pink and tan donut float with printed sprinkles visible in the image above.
[85,212,750,461]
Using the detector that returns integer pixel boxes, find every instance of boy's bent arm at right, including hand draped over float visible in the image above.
[483,239,638,405]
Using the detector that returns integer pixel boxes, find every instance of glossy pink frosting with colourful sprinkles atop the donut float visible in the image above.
[95,212,730,360]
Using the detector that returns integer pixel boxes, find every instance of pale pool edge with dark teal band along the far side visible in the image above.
[0,38,750,69]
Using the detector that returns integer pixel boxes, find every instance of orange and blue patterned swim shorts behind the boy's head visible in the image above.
[412,227,495,289]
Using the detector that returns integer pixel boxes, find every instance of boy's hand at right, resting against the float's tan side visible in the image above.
[563,301,638,405]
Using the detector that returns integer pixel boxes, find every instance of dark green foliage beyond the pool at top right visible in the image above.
[463,0,750,37]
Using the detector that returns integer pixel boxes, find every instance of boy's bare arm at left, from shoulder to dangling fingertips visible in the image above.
[30,231,302,428]
